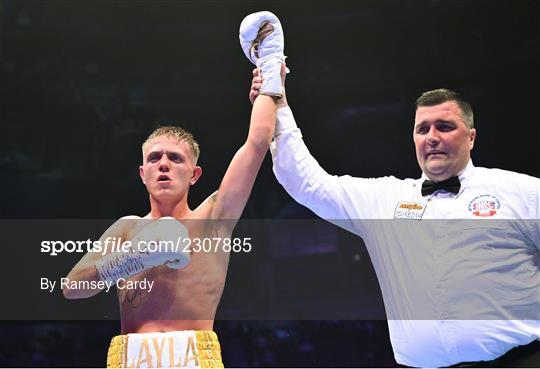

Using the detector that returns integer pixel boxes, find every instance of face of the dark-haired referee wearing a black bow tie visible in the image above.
[413,101,476,182]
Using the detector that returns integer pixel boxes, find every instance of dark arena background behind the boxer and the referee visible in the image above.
[0,0,540,367]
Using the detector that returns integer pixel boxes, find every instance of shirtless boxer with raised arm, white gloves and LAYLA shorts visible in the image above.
[63,13,284,367]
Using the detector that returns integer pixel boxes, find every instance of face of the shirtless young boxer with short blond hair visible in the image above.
[139,136,202,200]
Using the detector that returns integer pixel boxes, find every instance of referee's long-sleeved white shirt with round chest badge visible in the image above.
[271,107,540,367]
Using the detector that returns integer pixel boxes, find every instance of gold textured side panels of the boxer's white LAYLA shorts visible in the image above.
[107,331,223,368]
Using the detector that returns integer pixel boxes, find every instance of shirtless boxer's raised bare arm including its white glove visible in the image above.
[207,12,285,223]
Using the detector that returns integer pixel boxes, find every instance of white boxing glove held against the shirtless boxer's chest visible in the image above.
[95,217,189,283]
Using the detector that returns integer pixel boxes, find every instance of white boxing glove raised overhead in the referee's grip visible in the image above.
[240,11,285,97]
